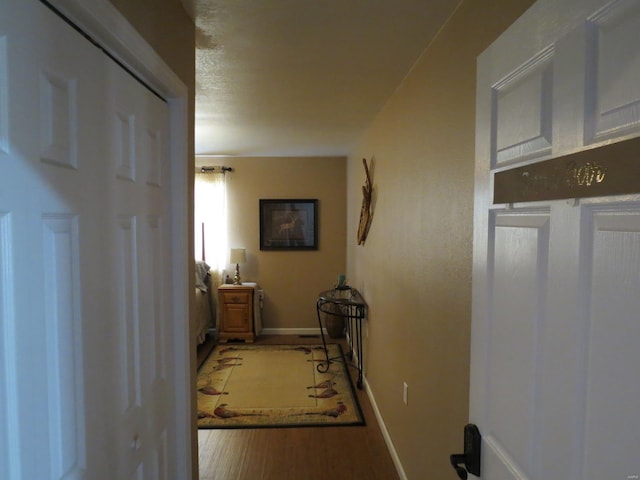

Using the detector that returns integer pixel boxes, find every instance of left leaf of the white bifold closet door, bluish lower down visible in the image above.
[0,1,102,479]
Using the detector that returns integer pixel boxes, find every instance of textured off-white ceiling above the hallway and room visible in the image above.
[182,0,459,156]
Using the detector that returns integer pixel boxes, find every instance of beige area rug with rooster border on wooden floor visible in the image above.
[197,344,365,428]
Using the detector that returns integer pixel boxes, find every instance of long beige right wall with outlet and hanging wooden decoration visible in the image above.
[347,0,533,479]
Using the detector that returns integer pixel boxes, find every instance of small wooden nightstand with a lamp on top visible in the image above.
[218,284,256,343]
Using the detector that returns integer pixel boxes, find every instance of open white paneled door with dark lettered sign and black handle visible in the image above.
[470,0,640,480]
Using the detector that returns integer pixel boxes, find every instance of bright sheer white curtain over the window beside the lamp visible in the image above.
[194,171,228,272]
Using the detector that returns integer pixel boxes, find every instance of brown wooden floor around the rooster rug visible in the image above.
[198,335,399,480]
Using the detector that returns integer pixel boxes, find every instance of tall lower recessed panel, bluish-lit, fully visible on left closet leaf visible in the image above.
[42,214,85,478]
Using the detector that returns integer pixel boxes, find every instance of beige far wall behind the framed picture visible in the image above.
[196,157,346,329]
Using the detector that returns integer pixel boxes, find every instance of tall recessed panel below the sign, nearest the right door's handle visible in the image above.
[484,210,549,472]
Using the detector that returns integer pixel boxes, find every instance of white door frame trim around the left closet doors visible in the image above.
[49,0,192,479]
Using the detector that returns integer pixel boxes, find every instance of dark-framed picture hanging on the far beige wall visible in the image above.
[260,199,318,250]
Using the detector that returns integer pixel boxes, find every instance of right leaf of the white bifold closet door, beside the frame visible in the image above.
[107,57,172,480]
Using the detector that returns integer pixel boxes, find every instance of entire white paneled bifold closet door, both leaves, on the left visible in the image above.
[0,0,184,480]
